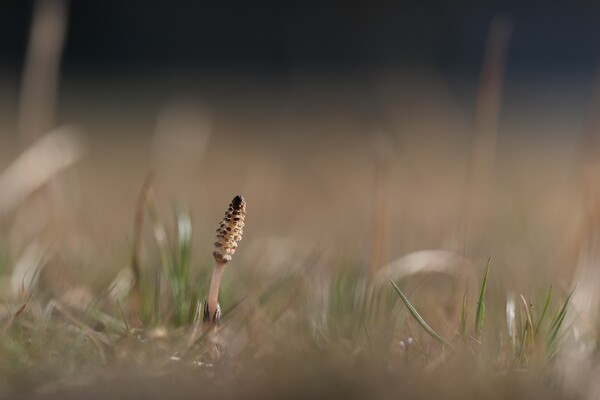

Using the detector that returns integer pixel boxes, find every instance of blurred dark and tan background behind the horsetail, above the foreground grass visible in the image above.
[0,0,600,294]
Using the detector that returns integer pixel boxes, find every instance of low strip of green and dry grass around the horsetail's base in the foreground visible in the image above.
[0,208,572,398]
